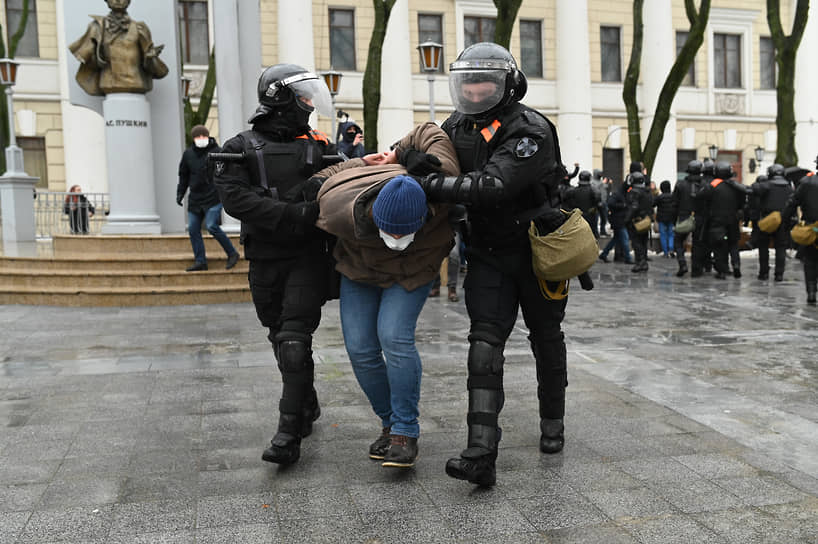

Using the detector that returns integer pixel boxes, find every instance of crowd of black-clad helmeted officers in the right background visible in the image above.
[564,159,818,304]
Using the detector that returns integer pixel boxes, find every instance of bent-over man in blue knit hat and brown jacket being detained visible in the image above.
[316,123,460,468]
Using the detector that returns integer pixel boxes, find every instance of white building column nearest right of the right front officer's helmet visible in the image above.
[556,0,593,170]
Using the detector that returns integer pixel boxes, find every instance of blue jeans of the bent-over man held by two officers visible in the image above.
[340,276,432,438]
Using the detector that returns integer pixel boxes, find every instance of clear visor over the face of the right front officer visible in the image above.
[449,69,507,115]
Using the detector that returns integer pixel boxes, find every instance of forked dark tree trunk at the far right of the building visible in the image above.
[767,0,809,166]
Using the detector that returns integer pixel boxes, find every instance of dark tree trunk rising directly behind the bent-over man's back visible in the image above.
[362,0,396,153]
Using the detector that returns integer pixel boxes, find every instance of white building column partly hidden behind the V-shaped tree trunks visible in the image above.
[641,0,677,186]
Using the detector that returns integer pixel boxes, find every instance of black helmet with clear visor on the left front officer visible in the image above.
[249,64,332,126]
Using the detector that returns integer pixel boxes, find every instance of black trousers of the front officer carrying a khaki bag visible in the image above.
[463,243,568,419]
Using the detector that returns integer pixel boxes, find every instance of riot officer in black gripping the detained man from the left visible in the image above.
[215,64,332,464]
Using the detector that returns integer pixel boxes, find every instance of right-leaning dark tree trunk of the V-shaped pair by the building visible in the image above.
[642,0,710,172]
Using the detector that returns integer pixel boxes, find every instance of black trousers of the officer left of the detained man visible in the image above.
[248,250,328,414]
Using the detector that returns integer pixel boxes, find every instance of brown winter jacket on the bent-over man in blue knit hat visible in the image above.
[316,123,460,291]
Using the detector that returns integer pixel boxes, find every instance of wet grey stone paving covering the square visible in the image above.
[0,248,818,544]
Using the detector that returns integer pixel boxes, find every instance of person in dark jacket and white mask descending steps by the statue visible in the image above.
[176,125,239,272]
